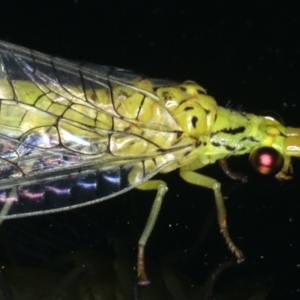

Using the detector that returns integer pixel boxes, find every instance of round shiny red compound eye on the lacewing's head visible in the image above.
[250,147,283,175]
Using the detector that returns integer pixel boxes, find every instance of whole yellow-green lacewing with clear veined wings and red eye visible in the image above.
[0,42,300,284]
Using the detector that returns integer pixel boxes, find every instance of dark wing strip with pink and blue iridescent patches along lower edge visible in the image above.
[0,166,131,219]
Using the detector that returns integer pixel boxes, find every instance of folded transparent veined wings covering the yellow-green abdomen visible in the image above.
[0,42,188,218]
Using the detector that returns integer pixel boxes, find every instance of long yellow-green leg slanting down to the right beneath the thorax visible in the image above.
[180,167,244,263]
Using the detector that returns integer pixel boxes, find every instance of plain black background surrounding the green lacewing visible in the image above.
[0,0,300,300]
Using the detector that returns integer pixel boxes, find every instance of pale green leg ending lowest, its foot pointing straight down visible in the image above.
[137,180,168,285]
